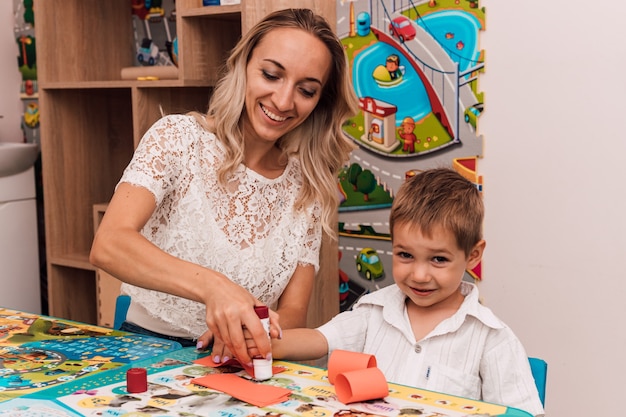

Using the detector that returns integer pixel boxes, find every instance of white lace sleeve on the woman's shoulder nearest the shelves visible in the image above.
[120,115,193,205]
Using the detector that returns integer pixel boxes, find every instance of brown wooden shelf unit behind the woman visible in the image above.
[35,0,339,326]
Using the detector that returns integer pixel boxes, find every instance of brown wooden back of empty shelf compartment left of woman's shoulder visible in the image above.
[40,89,133,258]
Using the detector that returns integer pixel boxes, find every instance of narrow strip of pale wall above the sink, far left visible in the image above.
[0,0,24,142]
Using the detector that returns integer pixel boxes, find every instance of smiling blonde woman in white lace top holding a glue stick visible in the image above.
[90,9,357,363]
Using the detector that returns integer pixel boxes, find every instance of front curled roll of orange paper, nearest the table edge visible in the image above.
[335,367,389,404]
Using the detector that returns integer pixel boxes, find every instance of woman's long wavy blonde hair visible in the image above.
[193,9,358,237]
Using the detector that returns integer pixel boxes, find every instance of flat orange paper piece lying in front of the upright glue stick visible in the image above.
[191,374,291,407]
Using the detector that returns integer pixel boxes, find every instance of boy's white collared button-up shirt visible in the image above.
[318,282,544,416]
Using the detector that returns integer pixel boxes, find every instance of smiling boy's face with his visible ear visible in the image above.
[393,224,485,309]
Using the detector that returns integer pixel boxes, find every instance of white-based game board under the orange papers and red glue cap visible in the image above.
[0,349,508,417]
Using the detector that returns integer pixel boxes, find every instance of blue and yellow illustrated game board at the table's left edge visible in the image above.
[0,307,181,402]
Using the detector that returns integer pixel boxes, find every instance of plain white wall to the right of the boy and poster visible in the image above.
[479,0,626,417]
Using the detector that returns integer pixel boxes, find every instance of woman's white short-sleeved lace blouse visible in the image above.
[120,115,321,338]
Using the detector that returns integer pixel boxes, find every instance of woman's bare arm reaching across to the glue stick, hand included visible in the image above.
[89,183,270,363]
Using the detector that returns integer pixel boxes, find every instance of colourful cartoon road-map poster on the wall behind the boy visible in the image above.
[337,0,485,310]
